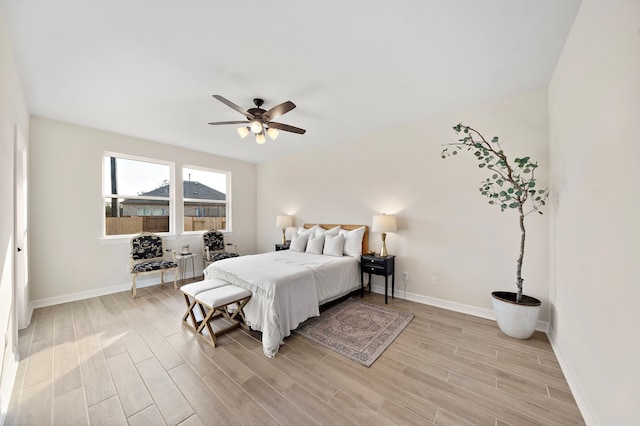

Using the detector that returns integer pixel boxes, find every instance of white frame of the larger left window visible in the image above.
[100,151,175,240]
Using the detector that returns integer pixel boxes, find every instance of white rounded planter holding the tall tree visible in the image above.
[491,291,542,339]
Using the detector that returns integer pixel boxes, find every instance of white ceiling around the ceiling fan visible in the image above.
[0,0,580,163]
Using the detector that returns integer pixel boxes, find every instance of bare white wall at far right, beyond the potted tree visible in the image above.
[549,0,640,425]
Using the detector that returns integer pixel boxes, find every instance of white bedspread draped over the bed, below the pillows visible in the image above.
[204,250,360,358]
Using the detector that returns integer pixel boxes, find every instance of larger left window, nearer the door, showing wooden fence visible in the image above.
[102,153,174,235]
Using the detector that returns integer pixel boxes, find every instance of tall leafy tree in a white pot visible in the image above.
[442,123,549,339]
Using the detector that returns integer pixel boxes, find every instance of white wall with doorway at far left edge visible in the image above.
[0,4,29,424]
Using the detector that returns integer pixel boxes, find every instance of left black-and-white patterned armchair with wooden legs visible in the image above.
[129,232,178,298]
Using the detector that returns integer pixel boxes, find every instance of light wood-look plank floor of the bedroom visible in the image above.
[5,285,584,426]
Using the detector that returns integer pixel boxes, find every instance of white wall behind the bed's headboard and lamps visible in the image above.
[257,90,548,321]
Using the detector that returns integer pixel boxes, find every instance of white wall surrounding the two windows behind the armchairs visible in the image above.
[29,117,256,306]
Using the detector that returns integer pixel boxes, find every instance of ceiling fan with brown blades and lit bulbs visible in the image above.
[209,95,306,144]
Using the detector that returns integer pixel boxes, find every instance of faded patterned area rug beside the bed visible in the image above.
[296,299,413,367]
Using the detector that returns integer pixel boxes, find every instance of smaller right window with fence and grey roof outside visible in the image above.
[182,166,231,232]
